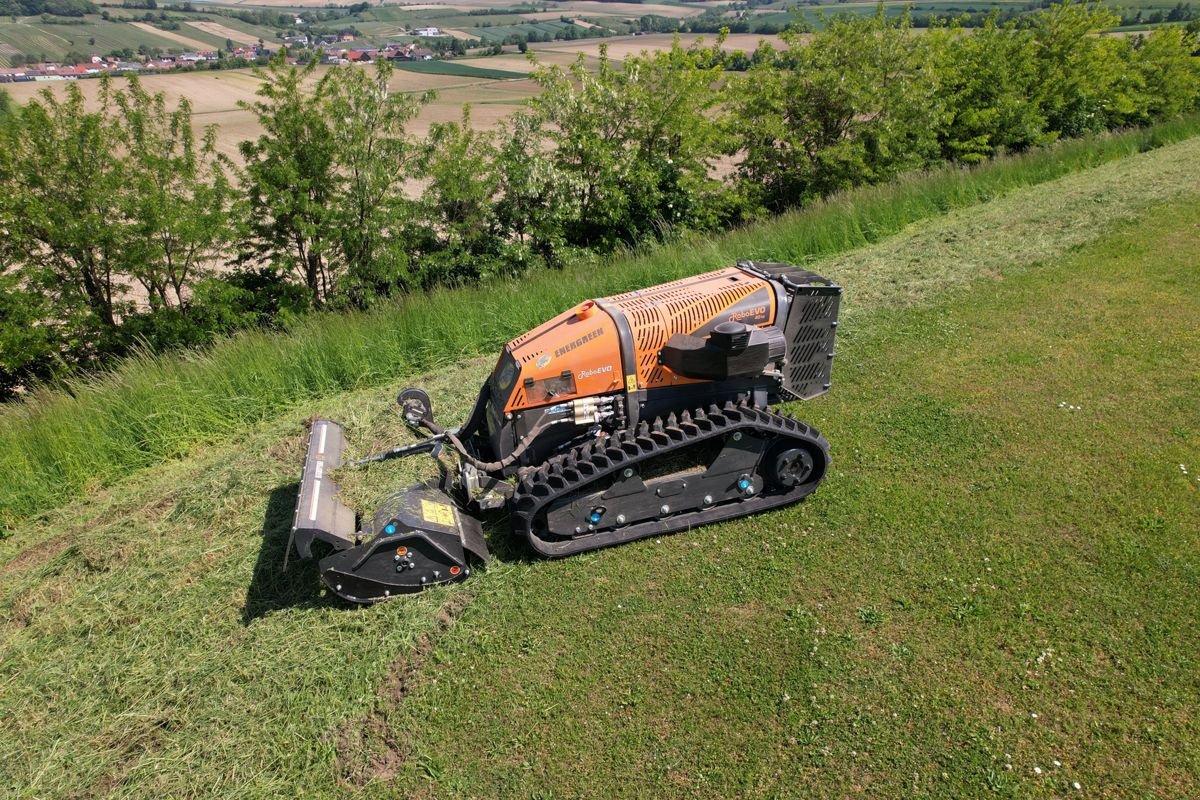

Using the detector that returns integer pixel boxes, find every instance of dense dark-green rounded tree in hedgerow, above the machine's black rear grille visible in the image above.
[733,7,944,211]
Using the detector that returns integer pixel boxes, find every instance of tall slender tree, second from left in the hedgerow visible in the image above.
[241,58,421,307]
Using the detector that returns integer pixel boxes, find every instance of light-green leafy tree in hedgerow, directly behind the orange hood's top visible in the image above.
[530,38,725,249]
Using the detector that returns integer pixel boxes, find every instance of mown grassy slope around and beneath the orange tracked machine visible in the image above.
[0,142,1200,796]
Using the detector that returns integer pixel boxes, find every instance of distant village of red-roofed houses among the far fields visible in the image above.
[0,34,438,83]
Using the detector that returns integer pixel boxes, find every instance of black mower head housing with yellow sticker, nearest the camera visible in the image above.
[320,486,488,603]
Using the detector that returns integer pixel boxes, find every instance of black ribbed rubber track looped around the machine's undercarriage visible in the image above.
[511,402,829,558]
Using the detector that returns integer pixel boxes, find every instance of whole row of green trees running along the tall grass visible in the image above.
[0,2,1200,397]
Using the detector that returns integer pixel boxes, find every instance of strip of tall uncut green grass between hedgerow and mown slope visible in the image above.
[0,118,1200,525]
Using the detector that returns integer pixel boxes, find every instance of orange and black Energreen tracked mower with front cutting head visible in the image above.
[285,261,841,603]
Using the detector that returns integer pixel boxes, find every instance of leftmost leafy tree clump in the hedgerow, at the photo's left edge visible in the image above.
[0,78,233,378]
